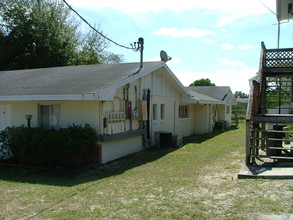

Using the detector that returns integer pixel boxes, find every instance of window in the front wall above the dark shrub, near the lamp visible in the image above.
[39,105,60,130]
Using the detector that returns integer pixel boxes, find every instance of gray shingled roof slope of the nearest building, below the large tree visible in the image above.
[0,62,162,96]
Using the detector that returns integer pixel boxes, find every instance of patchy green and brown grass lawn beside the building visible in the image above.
[0,124,293,219]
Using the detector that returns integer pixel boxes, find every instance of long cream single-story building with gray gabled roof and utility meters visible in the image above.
[0,62,231,163]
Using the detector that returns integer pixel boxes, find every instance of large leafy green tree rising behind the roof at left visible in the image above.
[0,0,123,70]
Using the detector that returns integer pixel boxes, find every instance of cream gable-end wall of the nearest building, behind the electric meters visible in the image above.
[101,70,185,163]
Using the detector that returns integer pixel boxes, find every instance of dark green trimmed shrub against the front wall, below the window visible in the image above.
[0,124,98,167]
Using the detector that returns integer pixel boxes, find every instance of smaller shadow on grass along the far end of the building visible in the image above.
[183,125,239,144]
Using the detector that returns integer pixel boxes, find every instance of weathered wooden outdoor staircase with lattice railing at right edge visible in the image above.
[246,43,293,165]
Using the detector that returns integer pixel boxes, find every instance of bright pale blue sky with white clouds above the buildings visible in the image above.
[67,0,293,93]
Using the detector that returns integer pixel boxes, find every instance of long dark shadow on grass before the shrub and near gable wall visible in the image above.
[0,148,173,187]
